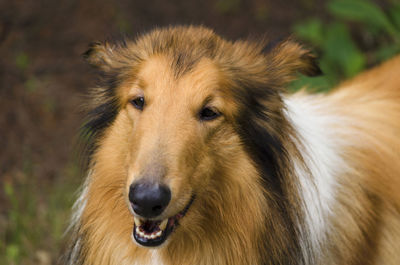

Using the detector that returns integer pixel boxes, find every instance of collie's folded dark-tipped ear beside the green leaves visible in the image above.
[267,40,322,80]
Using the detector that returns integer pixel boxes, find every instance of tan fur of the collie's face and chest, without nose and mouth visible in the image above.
[83,56,264,264]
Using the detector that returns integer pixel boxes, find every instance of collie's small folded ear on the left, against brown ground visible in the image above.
[83,42,116,72]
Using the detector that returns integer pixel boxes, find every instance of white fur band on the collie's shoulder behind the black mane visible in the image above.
[284,93,346,260]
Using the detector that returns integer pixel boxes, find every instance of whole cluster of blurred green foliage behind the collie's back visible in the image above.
[290,0,400,91]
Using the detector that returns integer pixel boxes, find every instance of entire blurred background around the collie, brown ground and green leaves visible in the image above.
[0,0,400,265]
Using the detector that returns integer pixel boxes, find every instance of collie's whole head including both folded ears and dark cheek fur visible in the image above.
[86,27,318,247]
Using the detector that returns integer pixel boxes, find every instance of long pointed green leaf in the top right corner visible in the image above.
[328,0,399,37]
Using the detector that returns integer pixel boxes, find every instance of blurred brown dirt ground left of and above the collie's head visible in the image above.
[0,0,388,264]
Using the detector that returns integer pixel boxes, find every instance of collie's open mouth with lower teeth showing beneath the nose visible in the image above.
[133,196,195,247]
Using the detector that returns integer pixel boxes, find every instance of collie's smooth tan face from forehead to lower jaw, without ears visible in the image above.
[124,55,239,246]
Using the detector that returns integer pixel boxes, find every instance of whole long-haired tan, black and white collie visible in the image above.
[63,26,400,265]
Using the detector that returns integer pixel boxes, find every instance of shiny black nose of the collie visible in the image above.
[129,182,171,218]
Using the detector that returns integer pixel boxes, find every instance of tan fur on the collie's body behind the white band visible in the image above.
[325,57,400,265]
